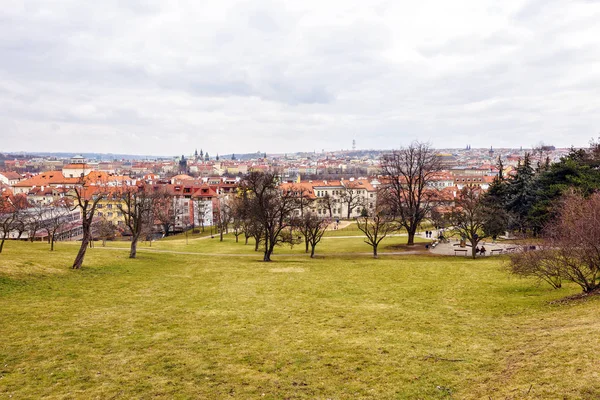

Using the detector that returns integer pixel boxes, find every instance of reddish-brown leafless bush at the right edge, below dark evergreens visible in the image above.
[509,193,600,293]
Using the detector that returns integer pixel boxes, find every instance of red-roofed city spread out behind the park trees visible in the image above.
[0,146,570,240]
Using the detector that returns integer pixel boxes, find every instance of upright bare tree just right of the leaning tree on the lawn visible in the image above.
[117,186,157,258]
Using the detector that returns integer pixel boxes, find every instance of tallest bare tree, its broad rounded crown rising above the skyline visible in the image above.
[381,142,441,245]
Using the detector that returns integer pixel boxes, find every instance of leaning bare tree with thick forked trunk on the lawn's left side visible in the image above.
[70,178,107,269]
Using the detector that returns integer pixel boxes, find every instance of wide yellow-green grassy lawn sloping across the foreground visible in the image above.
[0,237,600,399]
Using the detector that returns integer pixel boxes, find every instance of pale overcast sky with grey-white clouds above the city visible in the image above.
[0,0,600,155]
